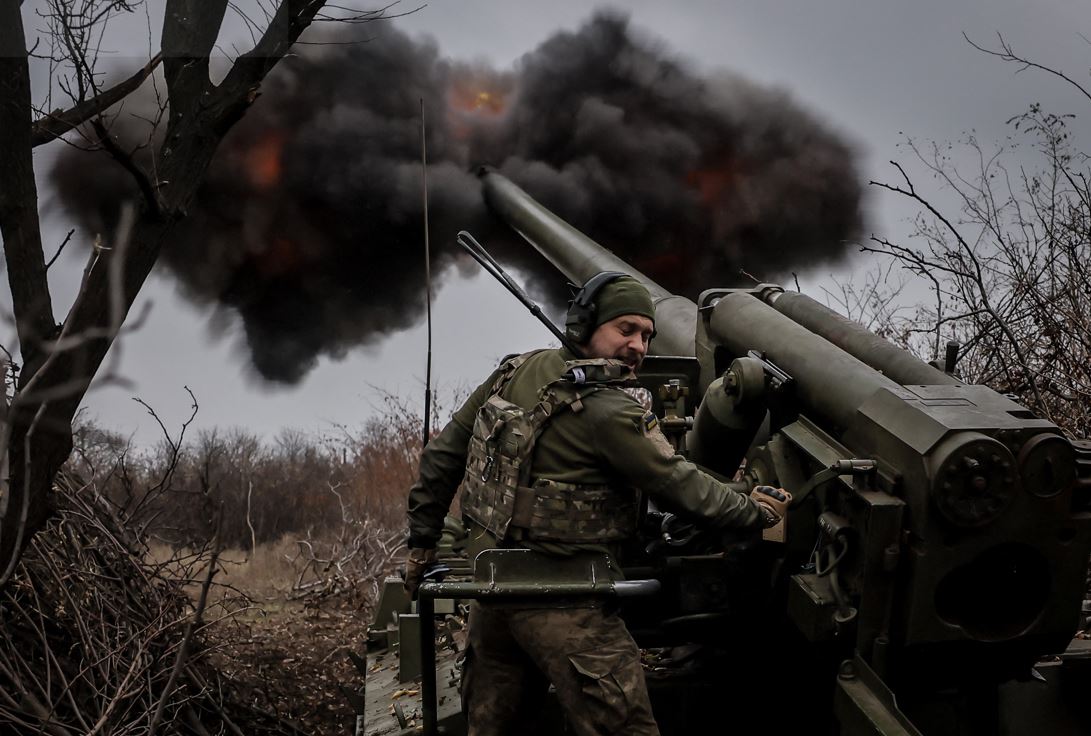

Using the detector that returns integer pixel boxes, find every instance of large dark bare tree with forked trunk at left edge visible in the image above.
[0,0,401,584]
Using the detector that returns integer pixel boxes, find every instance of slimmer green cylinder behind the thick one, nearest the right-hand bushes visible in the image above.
[765,291,961,386]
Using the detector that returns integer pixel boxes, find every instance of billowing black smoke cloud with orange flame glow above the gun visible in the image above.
[52,13,861,383]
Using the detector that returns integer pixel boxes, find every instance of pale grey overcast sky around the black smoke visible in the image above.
[17,0,1091,444]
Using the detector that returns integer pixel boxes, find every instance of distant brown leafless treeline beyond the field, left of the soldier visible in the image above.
[68,397,422,548]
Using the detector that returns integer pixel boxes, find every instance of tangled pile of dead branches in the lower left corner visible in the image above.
[0,468,292,736]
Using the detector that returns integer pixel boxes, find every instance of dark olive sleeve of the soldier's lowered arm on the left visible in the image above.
[408,372,499,548]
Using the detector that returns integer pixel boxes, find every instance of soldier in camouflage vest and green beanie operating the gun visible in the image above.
[406,272,791,736]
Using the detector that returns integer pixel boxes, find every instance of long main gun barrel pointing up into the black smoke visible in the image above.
[478,167,697,355]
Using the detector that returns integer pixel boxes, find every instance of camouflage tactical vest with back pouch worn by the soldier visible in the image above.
[461,352,639,543]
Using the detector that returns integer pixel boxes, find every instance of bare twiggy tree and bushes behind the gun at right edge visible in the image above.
[863,37,1091,436]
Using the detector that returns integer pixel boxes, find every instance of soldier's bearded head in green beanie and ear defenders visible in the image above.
[565,272,656,369]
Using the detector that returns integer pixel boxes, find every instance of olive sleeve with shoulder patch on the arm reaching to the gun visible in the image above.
[591,391,764,529]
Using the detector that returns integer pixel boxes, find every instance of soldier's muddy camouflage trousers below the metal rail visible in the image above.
[463,602,659,736]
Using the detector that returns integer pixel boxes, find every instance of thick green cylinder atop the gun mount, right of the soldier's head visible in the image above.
[709,292,903,429]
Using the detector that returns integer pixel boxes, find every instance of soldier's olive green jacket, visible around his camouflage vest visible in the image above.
[409,349,763,554]
